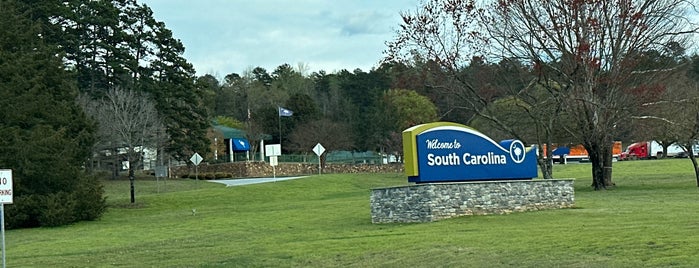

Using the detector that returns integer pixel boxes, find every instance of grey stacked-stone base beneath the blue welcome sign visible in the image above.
[371,179,575,223]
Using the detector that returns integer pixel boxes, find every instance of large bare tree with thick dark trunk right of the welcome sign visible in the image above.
[484,0,693,189]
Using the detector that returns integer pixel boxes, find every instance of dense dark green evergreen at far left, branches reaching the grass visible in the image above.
[0,0,106,228]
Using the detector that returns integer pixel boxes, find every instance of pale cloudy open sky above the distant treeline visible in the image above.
[140,0,419,77]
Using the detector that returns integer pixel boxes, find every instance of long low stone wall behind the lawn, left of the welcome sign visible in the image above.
[171,162,403,179]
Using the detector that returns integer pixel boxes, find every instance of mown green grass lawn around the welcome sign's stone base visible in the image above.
[6,159,699,267]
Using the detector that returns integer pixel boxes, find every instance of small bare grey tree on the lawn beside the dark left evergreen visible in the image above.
[87,88,167,203]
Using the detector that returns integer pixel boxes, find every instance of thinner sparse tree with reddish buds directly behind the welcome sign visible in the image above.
[386,0,560,179]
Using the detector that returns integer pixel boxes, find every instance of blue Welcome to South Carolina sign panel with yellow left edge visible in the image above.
[403,122,537,183]
